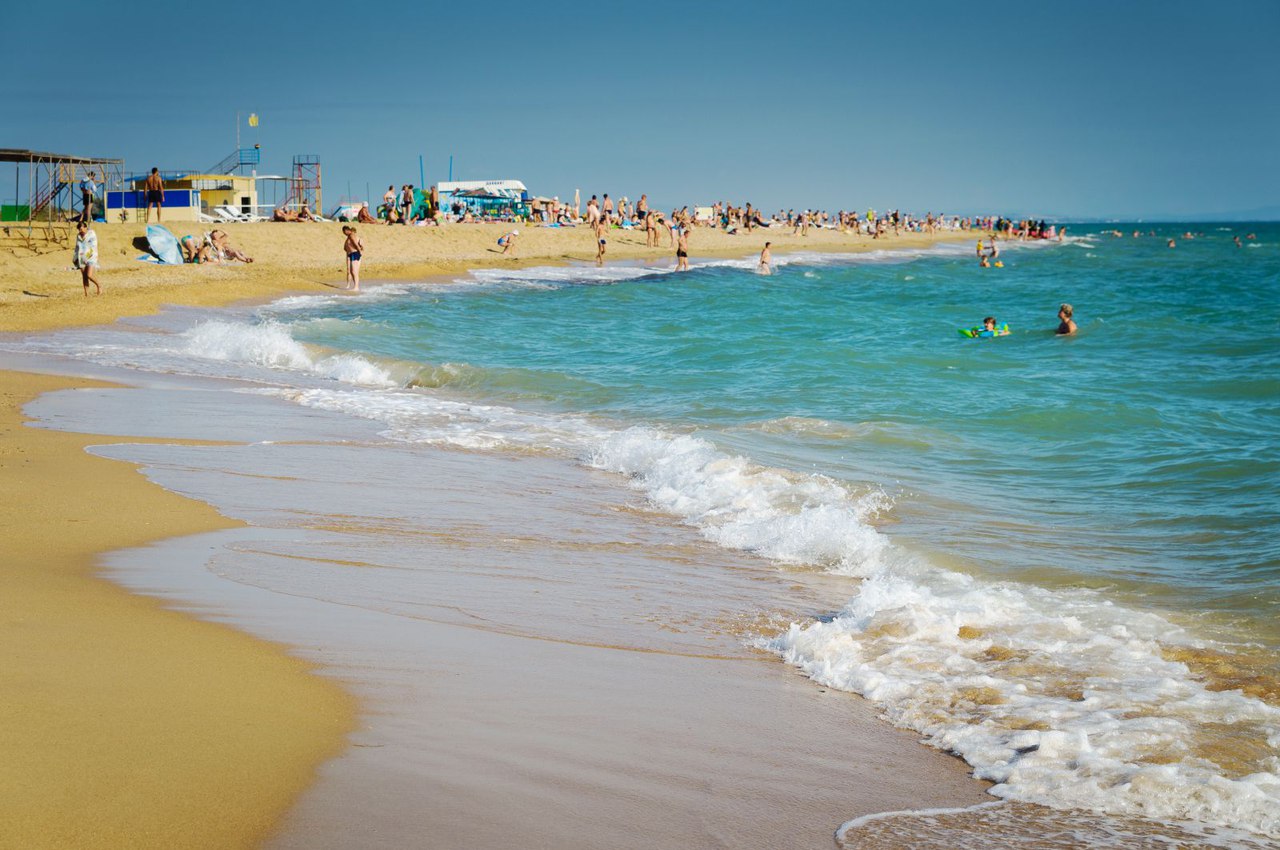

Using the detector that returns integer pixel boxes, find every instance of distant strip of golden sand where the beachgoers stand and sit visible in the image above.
[0,221,977,330]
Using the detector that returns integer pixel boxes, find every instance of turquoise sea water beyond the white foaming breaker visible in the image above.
[289,224,1280,636]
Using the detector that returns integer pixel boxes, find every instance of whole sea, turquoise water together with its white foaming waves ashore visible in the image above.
[0,223,1280,846]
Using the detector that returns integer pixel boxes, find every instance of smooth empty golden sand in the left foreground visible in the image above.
[0,373,355,849]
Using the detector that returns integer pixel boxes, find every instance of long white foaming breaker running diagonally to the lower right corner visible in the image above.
[259,376,1280,836]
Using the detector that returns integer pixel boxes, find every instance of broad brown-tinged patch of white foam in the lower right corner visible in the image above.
[759,565,1280,837]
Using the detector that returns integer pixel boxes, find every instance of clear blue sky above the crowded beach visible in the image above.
[0,0,1280,218]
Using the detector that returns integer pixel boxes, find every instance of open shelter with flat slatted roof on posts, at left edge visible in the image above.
[0,147,124,248]
